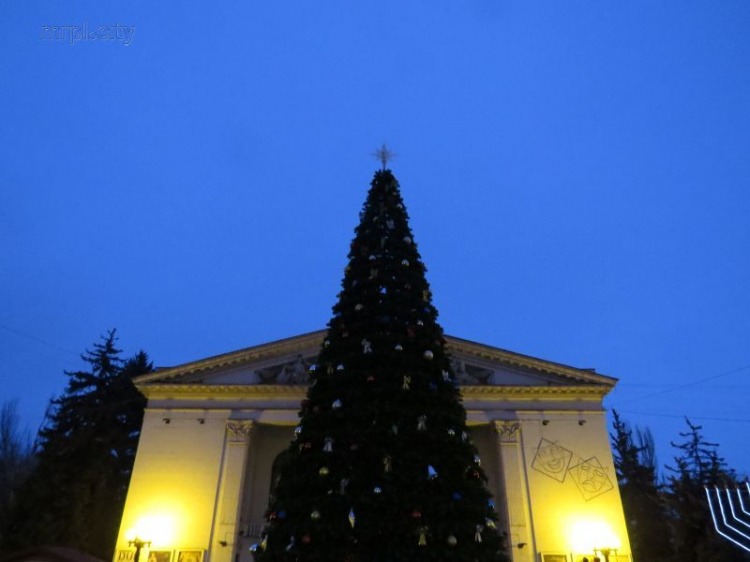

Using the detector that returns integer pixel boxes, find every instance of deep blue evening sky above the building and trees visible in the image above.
[0,0,750,472]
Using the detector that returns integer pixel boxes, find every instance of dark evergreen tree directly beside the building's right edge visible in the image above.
[611,410,672,560]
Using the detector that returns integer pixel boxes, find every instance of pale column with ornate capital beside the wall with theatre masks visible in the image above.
[495,420,536,562]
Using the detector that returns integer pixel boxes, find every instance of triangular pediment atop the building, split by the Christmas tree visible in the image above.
[135,331,616,390]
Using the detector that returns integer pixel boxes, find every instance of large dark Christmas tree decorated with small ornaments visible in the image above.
[253,164,506,562]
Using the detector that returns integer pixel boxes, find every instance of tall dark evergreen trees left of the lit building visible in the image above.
[4,331,152,560]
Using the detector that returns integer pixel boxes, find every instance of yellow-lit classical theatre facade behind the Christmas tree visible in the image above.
[115,331,631,562]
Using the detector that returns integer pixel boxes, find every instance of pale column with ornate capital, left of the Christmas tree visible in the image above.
[209,420,254,562]
